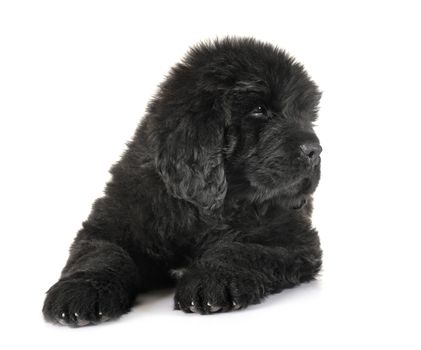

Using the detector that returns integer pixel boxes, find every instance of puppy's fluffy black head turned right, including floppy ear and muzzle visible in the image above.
[153,39,322,212]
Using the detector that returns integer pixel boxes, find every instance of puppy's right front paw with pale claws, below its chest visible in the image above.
[174,270,265,314]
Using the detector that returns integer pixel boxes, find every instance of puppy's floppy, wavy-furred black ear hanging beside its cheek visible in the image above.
[155,104,227,214]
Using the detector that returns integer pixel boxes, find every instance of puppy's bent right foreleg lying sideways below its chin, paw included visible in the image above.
[175,242,321,314]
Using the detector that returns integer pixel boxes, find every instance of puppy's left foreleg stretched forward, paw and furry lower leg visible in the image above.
[43,239,139,326]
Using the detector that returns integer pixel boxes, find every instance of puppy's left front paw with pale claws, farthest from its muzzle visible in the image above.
[42,278,130,327]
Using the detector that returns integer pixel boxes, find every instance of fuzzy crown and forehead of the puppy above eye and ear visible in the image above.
[178,38,321,119]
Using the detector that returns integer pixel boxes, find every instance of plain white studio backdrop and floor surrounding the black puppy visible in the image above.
[0,0,421,350]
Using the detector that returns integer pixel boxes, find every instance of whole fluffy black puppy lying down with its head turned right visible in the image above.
[43,38,322,326]
